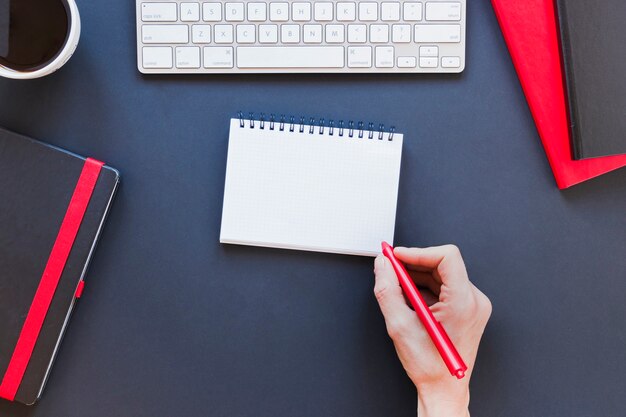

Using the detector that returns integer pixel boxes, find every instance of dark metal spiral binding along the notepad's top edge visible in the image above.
[237,111,396,141]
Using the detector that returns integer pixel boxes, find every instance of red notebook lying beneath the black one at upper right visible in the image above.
[491,0,626,189]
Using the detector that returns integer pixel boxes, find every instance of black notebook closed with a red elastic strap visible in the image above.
[0,129,119,404]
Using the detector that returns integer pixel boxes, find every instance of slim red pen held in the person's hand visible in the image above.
[382,242,467,379]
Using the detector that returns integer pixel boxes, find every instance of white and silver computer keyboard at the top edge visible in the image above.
[136,0,466,74]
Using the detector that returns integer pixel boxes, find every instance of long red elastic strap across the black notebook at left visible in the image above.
[0,158,104,401]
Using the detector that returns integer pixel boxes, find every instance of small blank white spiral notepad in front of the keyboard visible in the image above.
[220,115,403,256]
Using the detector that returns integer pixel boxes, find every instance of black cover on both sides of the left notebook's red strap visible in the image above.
[0,129,119,404]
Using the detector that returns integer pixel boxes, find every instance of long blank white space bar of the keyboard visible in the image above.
[237,46,344,68]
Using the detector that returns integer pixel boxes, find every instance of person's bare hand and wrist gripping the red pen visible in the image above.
[374,245,491,417]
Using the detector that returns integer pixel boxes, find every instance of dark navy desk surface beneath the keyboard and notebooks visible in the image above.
[0,0,626,417]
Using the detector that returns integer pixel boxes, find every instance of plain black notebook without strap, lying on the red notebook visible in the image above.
[556,0,626,159]
